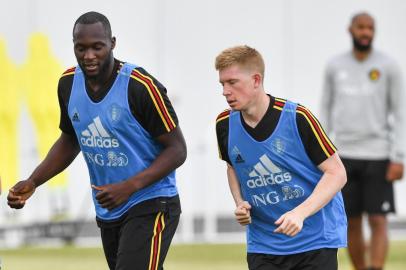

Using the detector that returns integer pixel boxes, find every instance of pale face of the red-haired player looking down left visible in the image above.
[219,65,258,111]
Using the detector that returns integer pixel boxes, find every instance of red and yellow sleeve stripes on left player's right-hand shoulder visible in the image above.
[131,69,176,132]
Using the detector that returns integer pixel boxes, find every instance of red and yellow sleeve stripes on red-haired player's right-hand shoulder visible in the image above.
[296,105,337,157]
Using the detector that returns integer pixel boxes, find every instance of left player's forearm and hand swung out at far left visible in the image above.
[7,132,80,209]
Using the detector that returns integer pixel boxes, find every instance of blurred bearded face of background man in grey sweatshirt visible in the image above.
[350,15,375,51]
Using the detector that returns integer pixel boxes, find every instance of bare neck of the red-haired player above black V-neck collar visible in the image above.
[241,91,271,128]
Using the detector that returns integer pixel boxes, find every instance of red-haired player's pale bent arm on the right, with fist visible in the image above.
[275,153,347,236]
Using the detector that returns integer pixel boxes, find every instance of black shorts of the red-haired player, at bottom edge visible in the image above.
[247,248,338,270]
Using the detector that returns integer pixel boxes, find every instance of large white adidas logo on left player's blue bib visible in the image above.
[80,116,120,148]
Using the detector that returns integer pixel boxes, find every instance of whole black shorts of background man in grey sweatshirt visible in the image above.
[342,158,395,217]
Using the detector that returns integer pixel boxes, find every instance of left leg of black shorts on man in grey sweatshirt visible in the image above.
[341,158,364,217]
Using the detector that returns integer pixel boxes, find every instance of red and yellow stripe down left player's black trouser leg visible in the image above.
[148,212,165,270]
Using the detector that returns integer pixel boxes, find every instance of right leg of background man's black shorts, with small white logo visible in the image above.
[363,160,395,214]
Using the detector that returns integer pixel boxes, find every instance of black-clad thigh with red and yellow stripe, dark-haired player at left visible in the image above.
[116,212,179,270]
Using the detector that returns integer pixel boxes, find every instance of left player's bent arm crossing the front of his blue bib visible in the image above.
[93,126,187,210]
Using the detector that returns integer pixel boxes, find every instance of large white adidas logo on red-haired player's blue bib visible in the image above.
[247,155,292,188]
